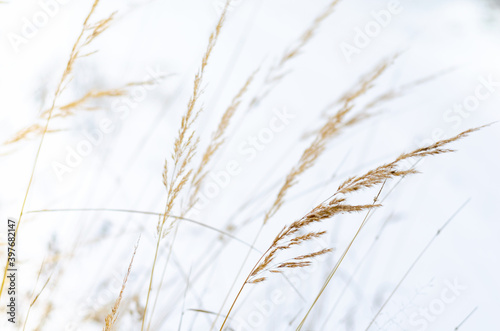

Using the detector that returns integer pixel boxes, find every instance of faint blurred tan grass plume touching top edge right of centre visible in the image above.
[249,0,340,109]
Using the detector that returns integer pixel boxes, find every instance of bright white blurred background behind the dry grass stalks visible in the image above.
[0,0,500,331]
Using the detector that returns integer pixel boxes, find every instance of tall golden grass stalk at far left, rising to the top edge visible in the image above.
[0,0,114,298]
